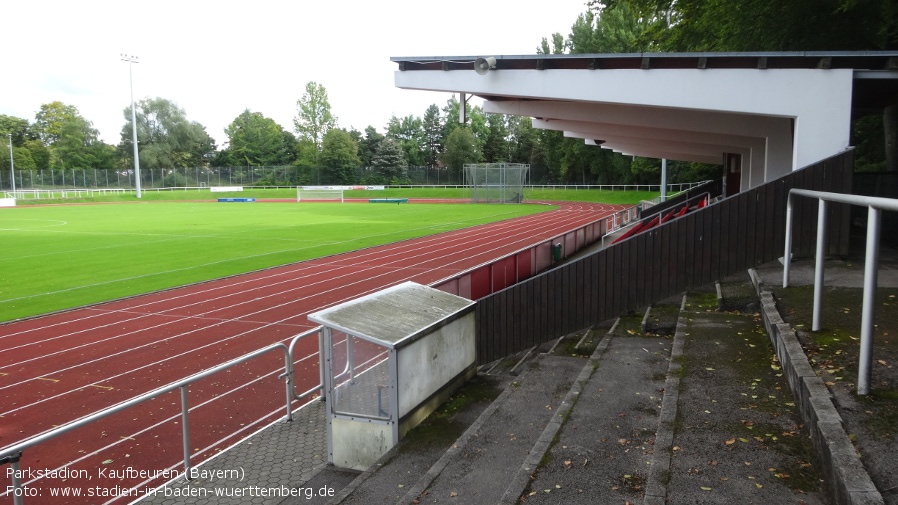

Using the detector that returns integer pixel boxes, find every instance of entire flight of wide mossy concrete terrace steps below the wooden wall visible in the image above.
[296,275,848,505]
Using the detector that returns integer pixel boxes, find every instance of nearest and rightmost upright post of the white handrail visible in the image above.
[857,207,882,395]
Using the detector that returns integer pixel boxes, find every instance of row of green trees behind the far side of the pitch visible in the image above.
[0,82,688,186]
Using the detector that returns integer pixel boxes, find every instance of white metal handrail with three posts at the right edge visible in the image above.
[783,189,898,395]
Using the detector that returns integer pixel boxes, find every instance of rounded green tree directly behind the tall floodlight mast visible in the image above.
[119,97,215,169]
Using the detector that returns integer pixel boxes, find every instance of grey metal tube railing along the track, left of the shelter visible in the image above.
[0,326,322,505]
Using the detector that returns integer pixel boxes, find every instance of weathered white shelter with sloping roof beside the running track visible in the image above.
[308,282,477,471]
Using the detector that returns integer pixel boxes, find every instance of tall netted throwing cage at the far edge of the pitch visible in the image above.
[465,163,530,203]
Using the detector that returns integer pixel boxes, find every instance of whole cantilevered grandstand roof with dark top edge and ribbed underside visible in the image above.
[392,52,898,188]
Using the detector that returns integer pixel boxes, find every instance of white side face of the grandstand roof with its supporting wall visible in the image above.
[395,68,853,177]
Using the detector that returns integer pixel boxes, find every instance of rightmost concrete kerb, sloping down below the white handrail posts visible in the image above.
[748,269,885,505]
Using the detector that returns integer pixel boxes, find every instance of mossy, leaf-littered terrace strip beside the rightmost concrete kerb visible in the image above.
[646,276,828,505]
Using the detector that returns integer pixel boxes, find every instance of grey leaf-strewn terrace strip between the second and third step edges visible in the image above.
[522,335,672,504]
